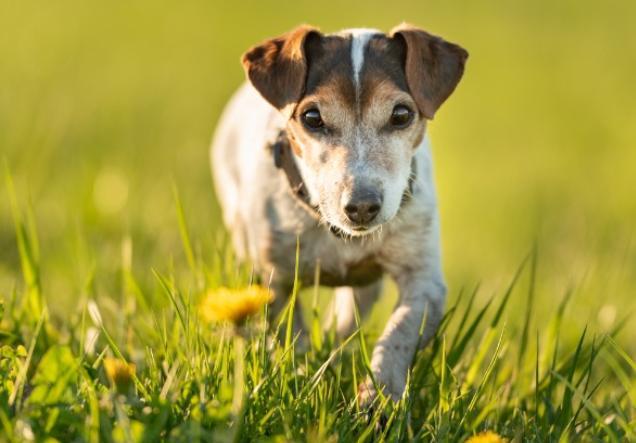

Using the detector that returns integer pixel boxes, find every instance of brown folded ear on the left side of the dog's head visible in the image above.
[242,25,320,115]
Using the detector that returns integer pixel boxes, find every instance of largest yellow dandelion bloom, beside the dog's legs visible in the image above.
[199,285,272,324]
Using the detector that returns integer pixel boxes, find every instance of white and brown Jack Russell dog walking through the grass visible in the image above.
[211,24,468,403]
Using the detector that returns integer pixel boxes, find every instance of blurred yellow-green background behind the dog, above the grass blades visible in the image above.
[0,0,636,350]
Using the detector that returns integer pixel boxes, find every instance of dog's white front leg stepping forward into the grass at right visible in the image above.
[360,272,446,404]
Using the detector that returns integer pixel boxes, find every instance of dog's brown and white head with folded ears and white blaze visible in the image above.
[243,25,468,235]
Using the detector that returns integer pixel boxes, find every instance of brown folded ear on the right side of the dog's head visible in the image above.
[391,24,468,119]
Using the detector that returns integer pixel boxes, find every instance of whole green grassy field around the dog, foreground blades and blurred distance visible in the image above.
[0,0,636,442]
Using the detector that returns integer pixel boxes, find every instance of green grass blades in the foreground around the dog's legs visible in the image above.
[0,181,636,442]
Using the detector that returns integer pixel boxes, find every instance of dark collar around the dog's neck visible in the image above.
[270,130,417,237]
